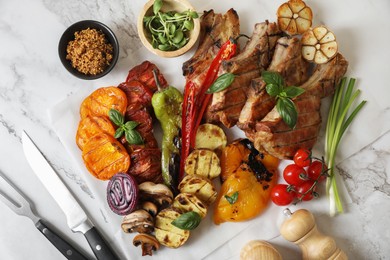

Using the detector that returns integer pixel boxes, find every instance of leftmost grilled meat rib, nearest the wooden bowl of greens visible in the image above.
[182,9,240,90]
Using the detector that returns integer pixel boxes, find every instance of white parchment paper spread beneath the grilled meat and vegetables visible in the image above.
[49,0,390,260]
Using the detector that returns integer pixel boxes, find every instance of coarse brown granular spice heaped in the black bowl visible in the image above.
[66,28,113,75]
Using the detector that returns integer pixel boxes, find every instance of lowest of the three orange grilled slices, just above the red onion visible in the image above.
[82,133,130,180]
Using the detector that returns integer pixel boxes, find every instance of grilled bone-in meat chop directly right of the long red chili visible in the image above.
[205,22,281,127]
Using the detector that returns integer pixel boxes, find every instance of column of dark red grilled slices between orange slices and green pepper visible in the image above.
[118,61,167,183]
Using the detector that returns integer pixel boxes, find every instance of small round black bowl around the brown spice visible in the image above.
[58,20,119,80]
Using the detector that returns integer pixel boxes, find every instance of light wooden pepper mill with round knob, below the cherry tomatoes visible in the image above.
[280,209,348,260]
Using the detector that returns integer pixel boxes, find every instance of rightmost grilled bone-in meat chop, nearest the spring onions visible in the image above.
[251,54,348,159]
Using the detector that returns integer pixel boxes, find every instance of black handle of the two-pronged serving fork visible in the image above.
[35,220,88,260]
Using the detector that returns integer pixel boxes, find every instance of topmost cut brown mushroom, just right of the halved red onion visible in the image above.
[138,181,173,209]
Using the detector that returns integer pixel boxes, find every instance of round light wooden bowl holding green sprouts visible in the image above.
[137,0,200,58]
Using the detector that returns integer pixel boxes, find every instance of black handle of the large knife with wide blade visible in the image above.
[84,227,119,260]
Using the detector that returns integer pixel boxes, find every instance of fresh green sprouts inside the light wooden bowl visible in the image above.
[143,0,199,51]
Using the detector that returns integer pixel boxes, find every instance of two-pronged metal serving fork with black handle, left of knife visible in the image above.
[0,171,88,260]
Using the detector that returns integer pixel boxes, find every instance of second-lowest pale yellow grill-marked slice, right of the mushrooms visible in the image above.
[172,193,207,218]
